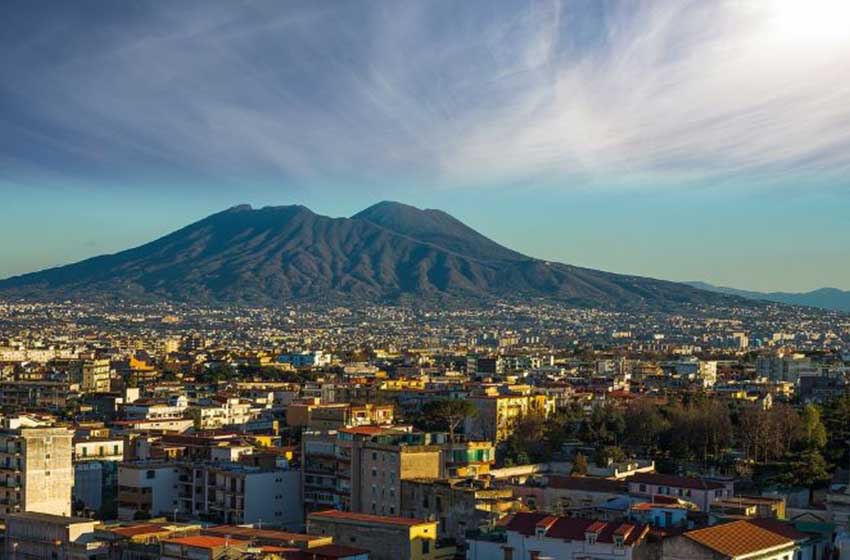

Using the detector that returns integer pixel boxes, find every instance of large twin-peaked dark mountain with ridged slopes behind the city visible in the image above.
[0,202,744,309]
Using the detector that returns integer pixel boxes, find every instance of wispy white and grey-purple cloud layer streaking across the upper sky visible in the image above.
[0,0,850,187]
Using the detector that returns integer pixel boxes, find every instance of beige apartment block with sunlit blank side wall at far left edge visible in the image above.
[0,417,74,515]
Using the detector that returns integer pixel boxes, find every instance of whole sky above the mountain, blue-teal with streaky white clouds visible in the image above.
[0,0,850,291]
